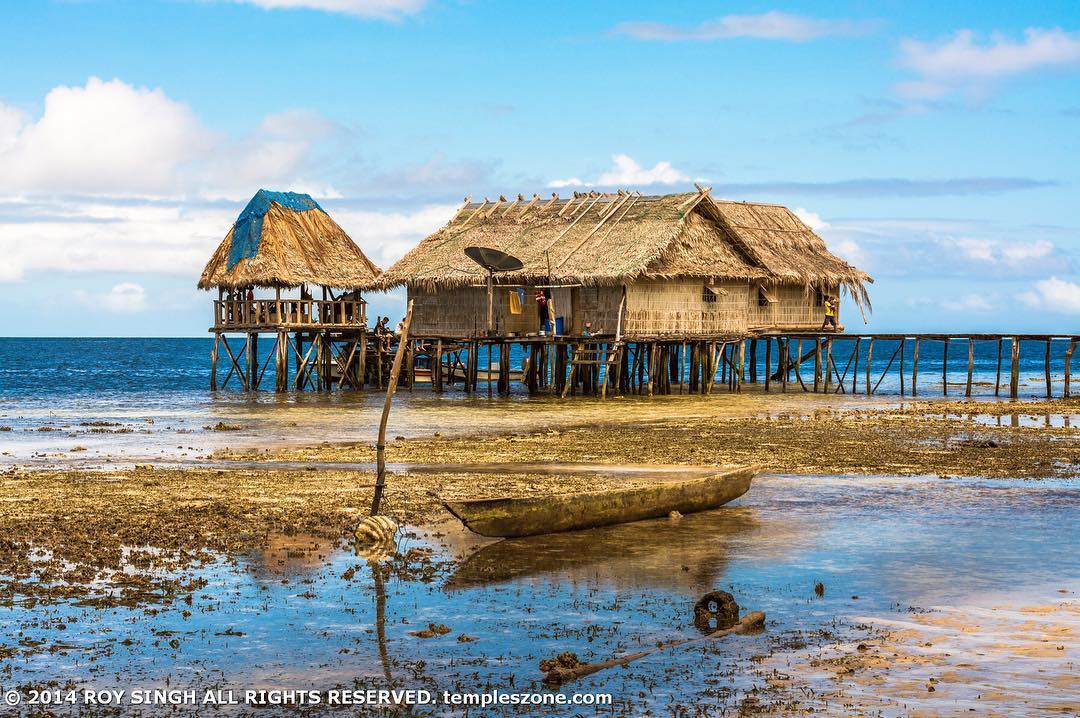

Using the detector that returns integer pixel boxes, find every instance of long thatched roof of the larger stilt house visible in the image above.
[379,189,873,304]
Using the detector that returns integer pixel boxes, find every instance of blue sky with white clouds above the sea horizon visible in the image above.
[0,0,1080,337]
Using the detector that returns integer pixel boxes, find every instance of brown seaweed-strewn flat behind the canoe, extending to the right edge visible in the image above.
[214,399,1080,478]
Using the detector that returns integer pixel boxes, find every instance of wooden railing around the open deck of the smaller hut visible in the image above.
[214,299,367,328]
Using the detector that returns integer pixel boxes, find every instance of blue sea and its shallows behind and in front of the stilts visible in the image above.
[0,338,1080,465]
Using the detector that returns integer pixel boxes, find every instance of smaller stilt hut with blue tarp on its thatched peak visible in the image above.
[199,189,380,391]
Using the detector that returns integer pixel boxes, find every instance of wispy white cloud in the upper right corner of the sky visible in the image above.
[895,28,1080,99]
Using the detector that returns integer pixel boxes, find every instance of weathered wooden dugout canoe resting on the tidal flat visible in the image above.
[443,466,759,538]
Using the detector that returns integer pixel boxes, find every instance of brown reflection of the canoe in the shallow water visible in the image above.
[442,506,761,596]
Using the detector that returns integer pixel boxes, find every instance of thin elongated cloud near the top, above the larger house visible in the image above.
[611,11,875,42]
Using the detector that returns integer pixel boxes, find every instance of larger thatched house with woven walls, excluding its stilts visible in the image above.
[379,189,873,336]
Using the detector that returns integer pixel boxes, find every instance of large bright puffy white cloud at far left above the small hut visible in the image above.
[0,77,339,199]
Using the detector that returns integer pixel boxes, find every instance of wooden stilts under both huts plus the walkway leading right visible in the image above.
[212,328,1080,398]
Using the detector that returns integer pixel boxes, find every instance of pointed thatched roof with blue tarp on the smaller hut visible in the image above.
[199,190,379,289]
